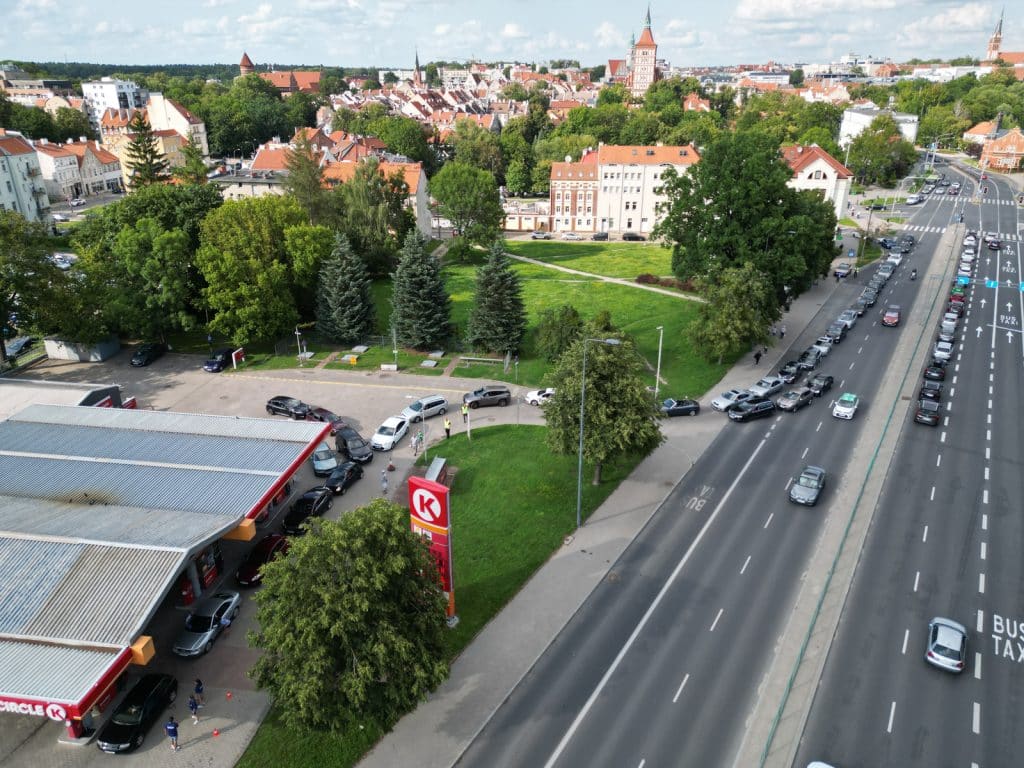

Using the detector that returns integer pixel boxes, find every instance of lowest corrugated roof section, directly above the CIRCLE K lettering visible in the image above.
[0,640,117,702]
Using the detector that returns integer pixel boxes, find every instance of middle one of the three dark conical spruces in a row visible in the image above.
[391,229,452,349]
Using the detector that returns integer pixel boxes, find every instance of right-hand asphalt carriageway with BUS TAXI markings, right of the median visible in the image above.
[795,166,1024,768]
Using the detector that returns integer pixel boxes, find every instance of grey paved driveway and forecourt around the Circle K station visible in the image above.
[0,349,543,768]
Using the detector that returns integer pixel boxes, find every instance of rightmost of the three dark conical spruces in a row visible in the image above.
[468,239,526,352]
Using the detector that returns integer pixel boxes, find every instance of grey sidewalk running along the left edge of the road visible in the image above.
[360,280,836,768]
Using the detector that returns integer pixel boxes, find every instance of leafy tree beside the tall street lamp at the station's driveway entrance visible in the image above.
[545,329,663,485]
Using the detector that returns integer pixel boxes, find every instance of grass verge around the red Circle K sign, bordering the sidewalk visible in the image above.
[238,425,640,768]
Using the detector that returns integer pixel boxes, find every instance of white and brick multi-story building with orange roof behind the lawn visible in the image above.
[549,144,700,233]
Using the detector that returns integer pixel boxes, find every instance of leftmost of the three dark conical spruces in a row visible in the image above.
[316,234,374,343]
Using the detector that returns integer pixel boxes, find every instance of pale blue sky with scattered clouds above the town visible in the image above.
[0,0,1007,69]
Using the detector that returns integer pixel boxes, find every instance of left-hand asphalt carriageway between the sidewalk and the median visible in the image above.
[459,176,950,768]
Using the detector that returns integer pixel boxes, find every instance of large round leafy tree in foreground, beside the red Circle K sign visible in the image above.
[249,499,447,730]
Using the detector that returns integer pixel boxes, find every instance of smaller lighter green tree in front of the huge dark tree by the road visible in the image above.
[688,263,780,365]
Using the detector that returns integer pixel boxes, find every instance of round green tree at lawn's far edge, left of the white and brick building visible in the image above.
[430,161,505,243]
